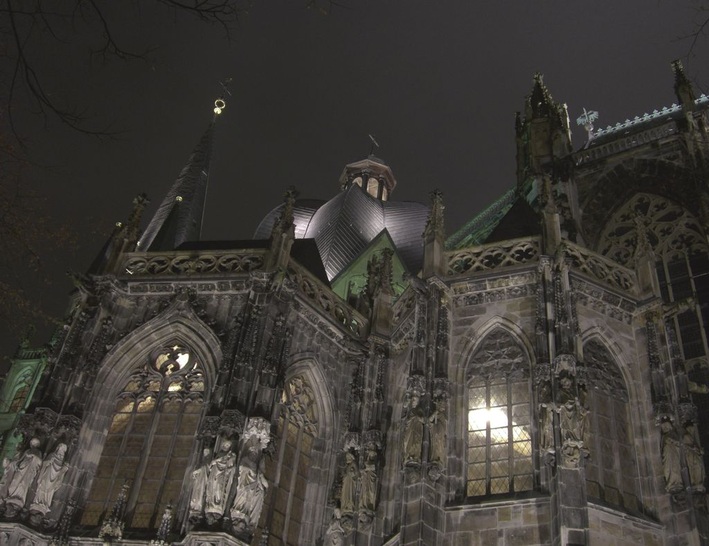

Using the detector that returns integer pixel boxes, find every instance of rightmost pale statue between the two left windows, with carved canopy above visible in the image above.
[231,418,270,533]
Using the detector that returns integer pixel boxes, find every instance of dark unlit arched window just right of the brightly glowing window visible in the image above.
[581,339,639,512]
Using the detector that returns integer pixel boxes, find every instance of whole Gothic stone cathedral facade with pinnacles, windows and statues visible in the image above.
[0,64,709,546]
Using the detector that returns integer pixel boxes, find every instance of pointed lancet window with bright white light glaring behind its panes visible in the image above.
[467,329,534,497]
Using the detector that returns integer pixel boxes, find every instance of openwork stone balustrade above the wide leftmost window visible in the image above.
[118,249,267,277]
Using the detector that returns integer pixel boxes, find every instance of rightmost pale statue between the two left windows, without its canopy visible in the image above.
[231,436,268,531]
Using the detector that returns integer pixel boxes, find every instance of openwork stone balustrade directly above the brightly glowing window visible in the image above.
[446,237,539,275]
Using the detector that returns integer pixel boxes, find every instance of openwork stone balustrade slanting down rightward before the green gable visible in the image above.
[287,263,367,338]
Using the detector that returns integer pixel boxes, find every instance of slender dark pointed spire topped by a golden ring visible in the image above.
[136,90,228,251]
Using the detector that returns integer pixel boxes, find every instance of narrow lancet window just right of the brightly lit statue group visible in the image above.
[257,375,319,545]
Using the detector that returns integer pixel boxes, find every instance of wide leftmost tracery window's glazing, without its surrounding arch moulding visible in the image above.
[81,345,204,529]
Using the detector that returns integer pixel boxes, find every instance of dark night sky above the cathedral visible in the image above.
[0,0,709,353]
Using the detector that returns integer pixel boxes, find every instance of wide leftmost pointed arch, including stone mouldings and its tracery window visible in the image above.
[77,299,222,529]
